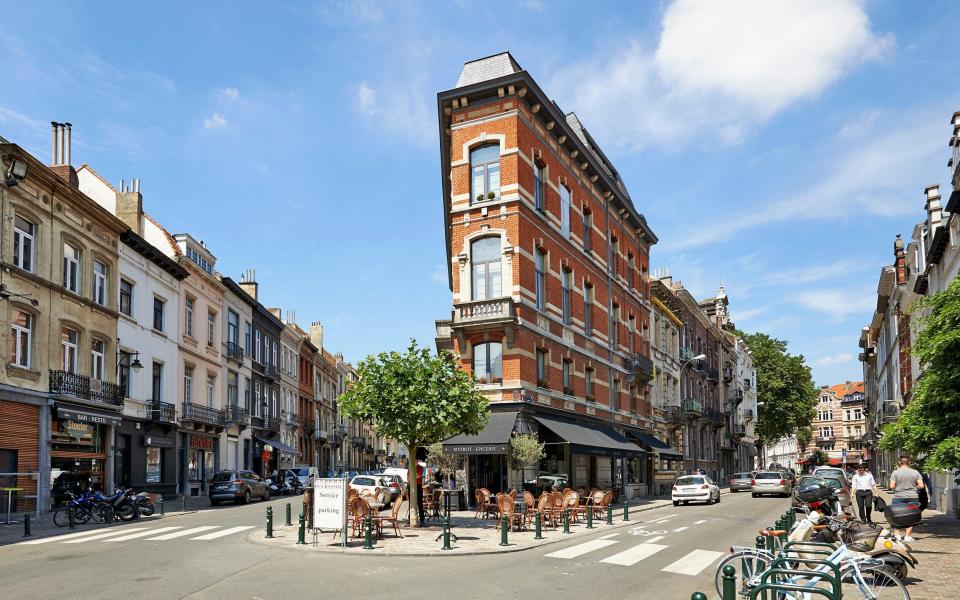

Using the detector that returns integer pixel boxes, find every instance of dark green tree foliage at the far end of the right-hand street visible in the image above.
[738,332,818,444]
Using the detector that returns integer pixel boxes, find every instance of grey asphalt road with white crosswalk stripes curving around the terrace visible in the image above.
[0,494,788,600]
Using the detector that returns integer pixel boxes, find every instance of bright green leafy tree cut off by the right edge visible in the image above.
[879,278,960,473]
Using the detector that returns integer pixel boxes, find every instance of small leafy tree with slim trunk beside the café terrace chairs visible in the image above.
[338,340,489,527]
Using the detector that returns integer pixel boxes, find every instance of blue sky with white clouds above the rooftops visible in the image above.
[0,0,960,384]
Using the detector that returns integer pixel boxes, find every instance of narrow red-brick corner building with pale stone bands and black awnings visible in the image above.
[437,52,666,497]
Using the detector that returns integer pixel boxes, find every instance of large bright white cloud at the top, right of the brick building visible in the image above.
[549,0,893,149]
